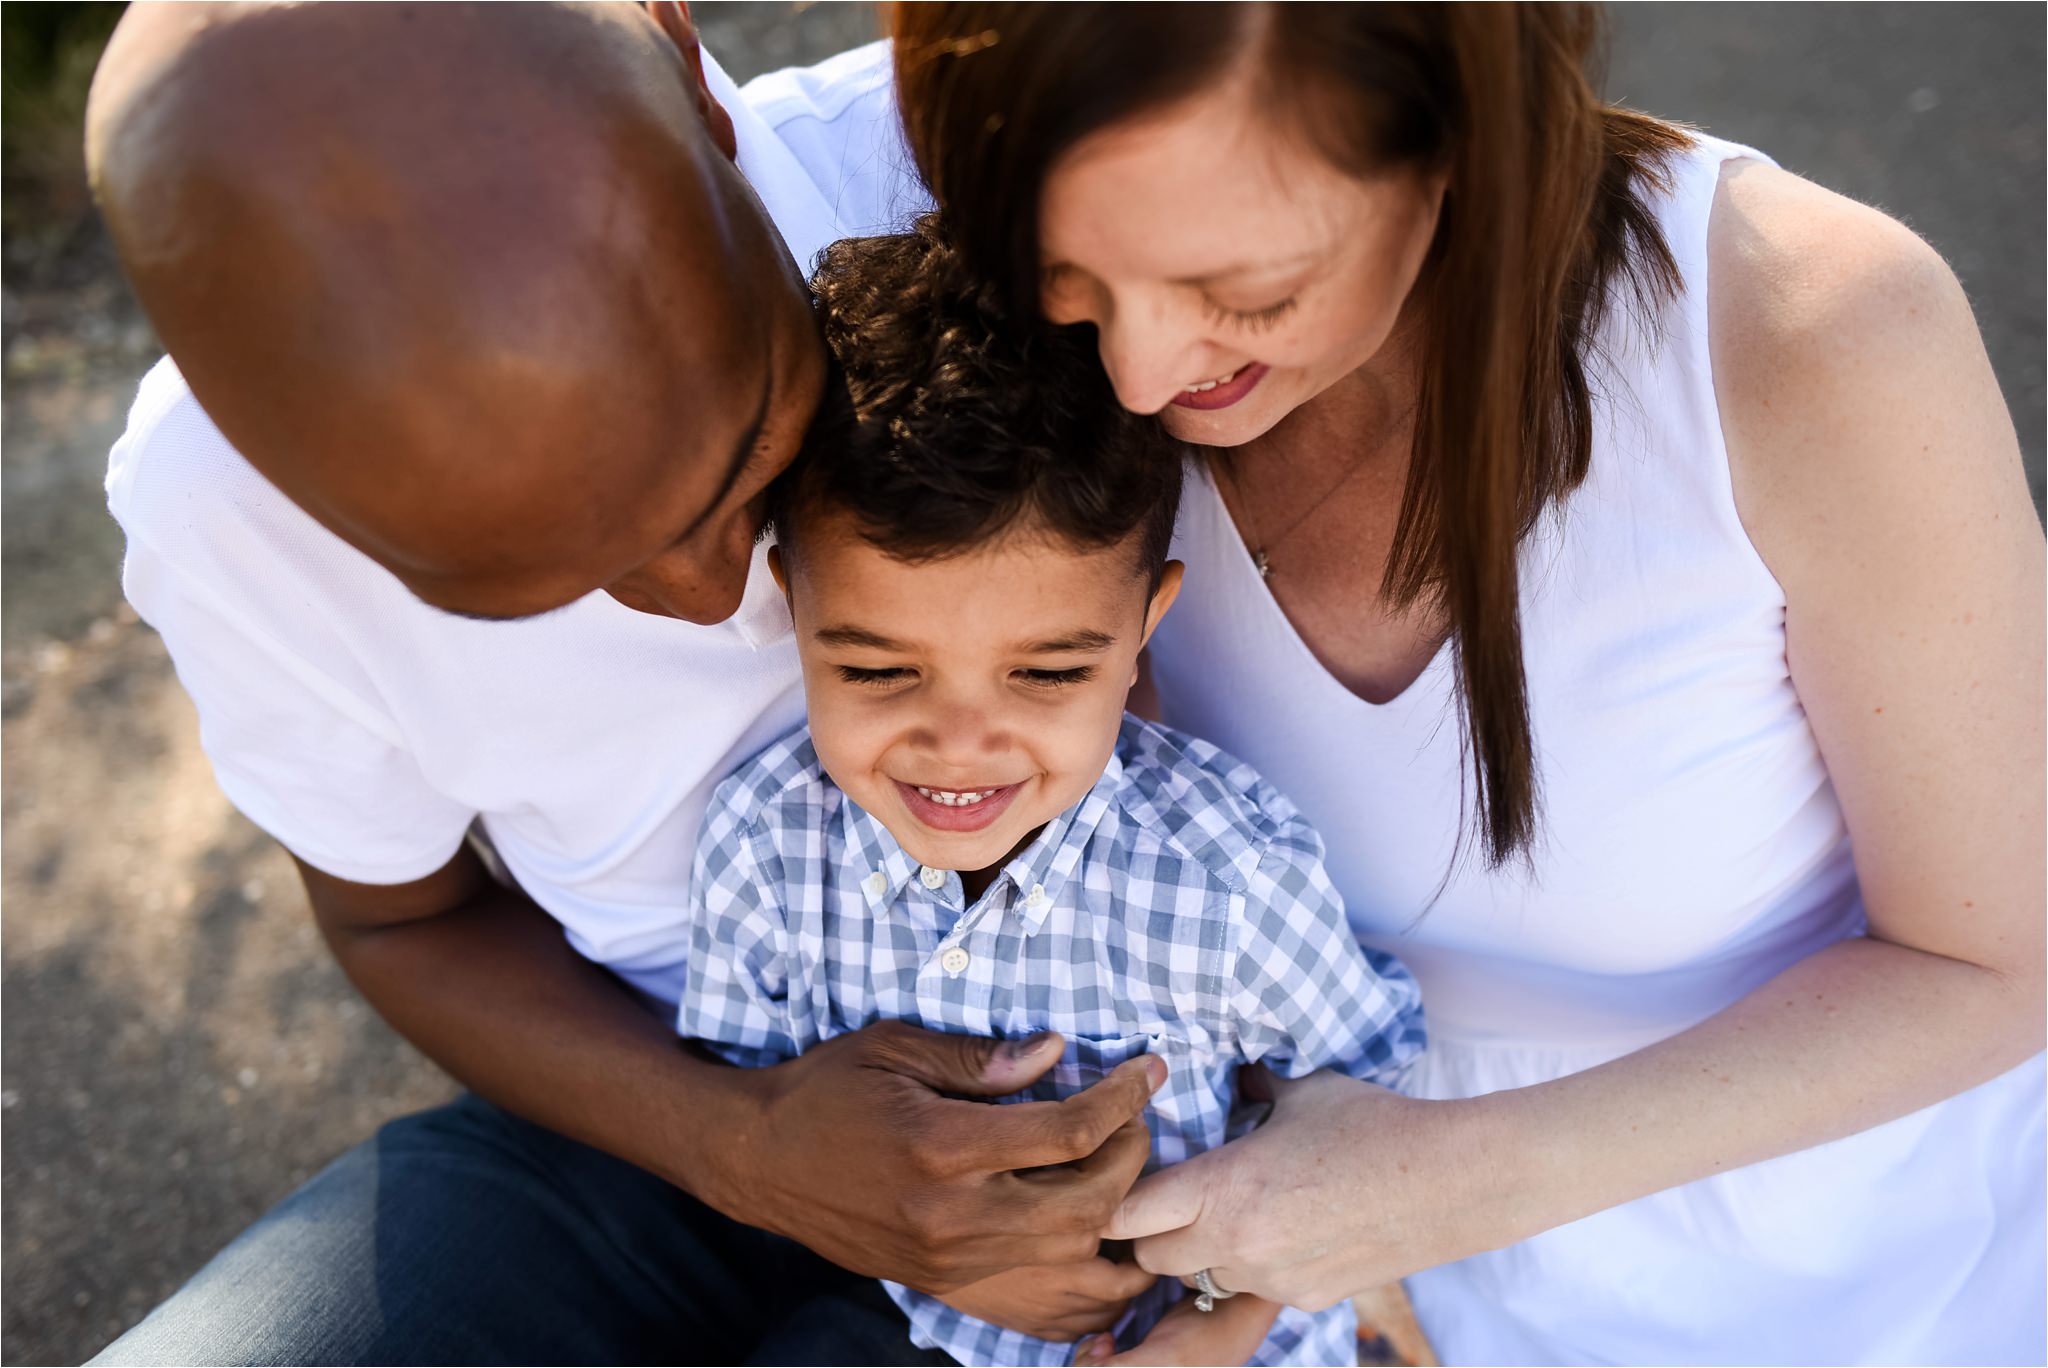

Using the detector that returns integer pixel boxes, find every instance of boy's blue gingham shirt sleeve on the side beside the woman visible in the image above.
[1233,817,1423,1083]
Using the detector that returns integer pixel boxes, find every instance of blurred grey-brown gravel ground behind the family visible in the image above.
[0,4,2044,1364]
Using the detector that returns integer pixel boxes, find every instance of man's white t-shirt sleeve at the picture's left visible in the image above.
[106,374,475,885]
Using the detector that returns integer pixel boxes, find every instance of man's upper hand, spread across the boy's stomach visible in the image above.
[712,1022,1165,1292]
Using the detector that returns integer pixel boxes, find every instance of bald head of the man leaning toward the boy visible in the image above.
[86,4,823,621]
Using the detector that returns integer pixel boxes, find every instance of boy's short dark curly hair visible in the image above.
[768,215,1182,588]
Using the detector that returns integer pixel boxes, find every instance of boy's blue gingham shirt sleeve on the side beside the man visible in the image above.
[676,806,799,1069]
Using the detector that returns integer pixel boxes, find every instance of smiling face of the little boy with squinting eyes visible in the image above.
[770,514,1180,870]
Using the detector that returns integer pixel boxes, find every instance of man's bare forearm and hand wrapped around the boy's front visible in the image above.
[299,848,1165,1290]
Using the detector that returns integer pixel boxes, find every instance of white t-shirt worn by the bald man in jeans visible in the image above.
[106,43,926,1003]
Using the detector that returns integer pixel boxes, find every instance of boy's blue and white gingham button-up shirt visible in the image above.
[680,717,1423,1364]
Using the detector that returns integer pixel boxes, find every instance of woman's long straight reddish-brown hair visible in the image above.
[891,2,1690,864]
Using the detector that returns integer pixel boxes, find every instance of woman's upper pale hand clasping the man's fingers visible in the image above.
[1108,1071,1540,1315]
